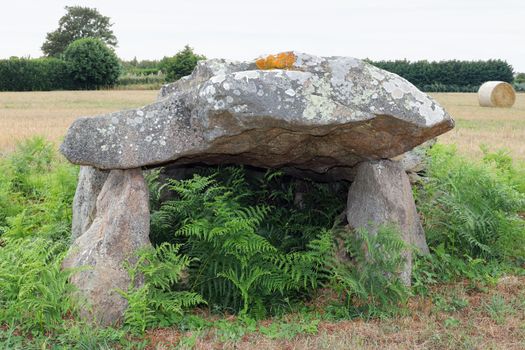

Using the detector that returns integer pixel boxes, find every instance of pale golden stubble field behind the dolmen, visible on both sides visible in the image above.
[0,90,525,160]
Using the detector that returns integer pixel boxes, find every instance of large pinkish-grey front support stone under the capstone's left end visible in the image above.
[63,169,150,325]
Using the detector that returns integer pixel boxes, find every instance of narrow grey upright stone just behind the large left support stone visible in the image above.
[71,166,109,240]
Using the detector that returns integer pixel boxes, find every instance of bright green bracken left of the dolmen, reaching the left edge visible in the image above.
[0,138,78,331]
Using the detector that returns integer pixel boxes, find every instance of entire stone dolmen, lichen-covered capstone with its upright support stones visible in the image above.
[60,52,454,325]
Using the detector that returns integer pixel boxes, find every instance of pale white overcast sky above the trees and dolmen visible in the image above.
[0,0,525,72]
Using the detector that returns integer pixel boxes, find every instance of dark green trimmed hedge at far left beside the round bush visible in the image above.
[0,57,73,91]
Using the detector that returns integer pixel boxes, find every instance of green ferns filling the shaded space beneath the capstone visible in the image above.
[140,167,414,317]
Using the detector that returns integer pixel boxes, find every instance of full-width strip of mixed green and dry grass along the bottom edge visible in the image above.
[0,276,525,350]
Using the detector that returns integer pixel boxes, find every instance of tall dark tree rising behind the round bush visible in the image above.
[42,6,117,56]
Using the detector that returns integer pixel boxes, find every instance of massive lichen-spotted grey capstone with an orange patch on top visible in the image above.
[61,52,454,178]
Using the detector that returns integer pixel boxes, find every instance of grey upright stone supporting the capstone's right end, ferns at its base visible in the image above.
[346,160,428,285]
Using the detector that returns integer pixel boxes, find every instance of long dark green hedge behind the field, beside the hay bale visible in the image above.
[370,60,514,92]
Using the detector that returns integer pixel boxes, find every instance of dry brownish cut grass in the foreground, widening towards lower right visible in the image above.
[147,276,525,350]
